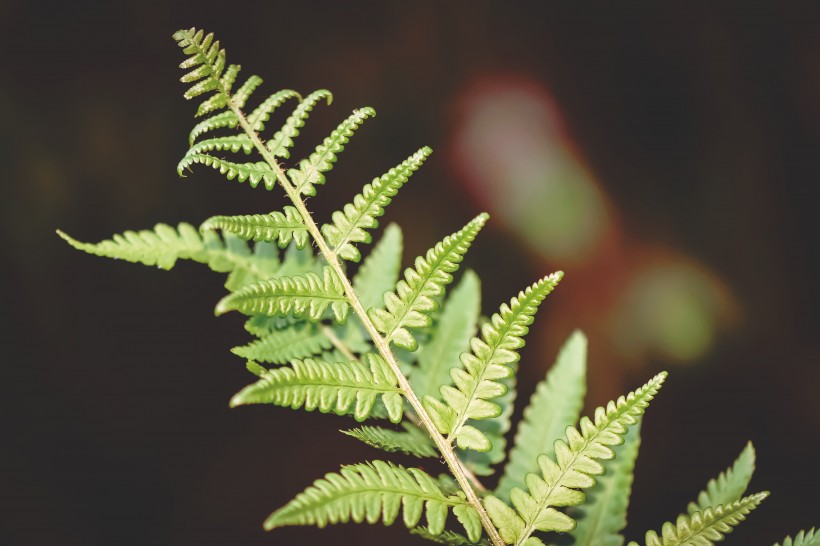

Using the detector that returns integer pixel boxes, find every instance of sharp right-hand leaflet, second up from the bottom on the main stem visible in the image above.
[424,272,563,451]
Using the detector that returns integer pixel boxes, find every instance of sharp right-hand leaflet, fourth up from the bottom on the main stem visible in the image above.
[322,147,433,262]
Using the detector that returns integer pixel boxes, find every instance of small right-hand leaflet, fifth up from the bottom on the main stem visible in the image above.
[288,107,376,196]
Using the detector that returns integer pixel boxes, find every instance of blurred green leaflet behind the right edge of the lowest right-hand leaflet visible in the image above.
[567,423,641,546]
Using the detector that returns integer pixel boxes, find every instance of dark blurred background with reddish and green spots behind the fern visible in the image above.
[0,0,820,546]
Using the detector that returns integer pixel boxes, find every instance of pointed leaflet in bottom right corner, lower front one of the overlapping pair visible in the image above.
[629,492,769,546]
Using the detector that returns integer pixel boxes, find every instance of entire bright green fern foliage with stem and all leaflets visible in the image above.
[58,29,820,546]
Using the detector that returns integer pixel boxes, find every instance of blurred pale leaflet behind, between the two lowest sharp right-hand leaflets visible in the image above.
[495,330,587,501]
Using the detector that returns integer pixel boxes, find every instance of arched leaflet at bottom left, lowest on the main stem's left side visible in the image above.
[265,461,473,535]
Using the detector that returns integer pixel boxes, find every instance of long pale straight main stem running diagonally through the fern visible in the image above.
[222,94,505,546]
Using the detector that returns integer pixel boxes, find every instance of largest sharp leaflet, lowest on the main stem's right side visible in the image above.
[484,372,666,546]
